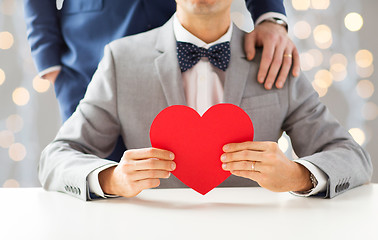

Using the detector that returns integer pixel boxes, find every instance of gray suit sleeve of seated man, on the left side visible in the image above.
[38,46,120,200]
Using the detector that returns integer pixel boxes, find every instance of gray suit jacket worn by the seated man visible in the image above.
[39,20,372,200]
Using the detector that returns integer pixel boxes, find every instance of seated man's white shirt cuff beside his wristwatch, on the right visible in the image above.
[290,160,328,197]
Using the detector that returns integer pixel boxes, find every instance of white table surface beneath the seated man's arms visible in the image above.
[0,184,378,240]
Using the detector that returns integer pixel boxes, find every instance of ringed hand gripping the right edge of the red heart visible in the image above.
[221,142,312,192]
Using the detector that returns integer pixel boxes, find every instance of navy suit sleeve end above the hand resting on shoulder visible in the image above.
[246,0,286,23]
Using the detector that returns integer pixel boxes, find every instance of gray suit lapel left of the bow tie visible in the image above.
[155,18,186,106]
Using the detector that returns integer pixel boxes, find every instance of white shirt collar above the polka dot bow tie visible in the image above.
[173,14,233,49]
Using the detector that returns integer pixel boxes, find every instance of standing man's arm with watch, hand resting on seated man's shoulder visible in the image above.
[245,0,300,89]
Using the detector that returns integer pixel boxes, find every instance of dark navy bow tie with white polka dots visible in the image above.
[177,42,231,72]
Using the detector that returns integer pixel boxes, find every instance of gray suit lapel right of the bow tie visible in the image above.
[223,25,255,106]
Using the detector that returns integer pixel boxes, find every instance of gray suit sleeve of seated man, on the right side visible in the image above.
[282,74,372,198]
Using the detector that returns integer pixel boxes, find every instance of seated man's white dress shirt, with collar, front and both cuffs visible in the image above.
[87,15,327,197]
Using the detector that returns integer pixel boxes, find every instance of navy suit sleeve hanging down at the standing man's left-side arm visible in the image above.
[24,0,64,72]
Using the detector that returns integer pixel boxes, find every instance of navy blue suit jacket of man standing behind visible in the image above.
[24,0,285,120]
